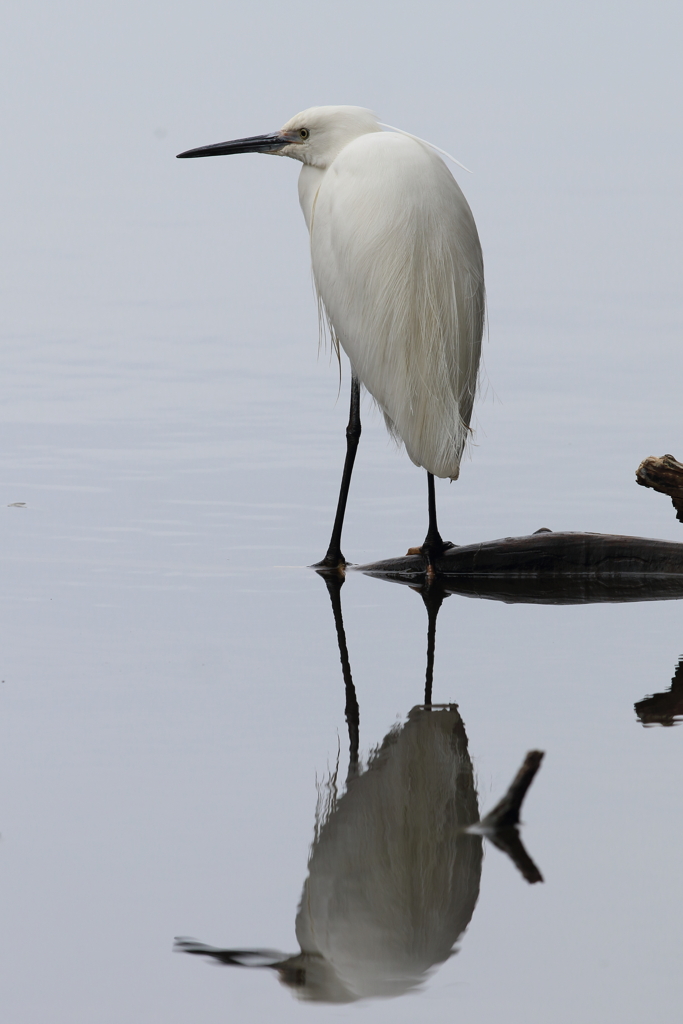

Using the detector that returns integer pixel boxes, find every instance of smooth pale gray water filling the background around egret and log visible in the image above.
[0,0,683,1024]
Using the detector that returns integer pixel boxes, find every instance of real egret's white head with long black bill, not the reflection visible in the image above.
[178,106,382,169]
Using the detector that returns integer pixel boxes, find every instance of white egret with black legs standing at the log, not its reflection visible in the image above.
[178,106,484,567]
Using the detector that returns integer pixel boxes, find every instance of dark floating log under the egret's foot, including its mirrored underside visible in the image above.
[357,529,683,604]
